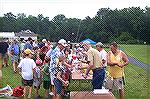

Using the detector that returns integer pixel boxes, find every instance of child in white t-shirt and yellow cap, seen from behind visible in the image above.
[18,49,36,99]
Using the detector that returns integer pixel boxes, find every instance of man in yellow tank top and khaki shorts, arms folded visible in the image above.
[107,42,129,99]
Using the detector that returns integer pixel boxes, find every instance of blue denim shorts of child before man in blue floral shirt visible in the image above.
[54,78,63,95]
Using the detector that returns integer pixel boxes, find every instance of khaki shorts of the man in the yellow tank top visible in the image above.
[105,77,124,89]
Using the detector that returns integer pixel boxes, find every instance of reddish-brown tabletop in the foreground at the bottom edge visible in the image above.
[70,91,116,99]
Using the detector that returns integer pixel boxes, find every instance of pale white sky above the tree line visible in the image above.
[0,0,150,19]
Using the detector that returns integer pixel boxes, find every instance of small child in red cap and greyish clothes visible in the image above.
[33,61,42,98]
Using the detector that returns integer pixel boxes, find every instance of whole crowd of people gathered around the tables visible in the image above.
[0,38,128,99]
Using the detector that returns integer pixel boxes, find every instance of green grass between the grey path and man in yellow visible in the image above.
[125,64,150,99]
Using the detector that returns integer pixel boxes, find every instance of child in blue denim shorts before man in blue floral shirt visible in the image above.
[54,56,69,99]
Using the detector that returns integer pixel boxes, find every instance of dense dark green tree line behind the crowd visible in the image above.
[0,7,150,44]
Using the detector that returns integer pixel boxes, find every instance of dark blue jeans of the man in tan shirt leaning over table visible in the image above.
[92,68,105,90]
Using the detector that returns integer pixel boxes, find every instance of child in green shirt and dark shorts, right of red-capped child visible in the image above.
[42,57,50,99]
